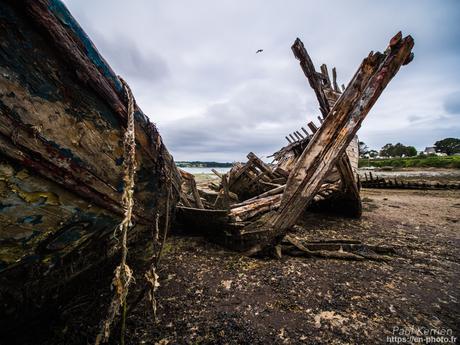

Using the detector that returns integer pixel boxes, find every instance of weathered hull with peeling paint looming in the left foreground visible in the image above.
[0,0,180,344]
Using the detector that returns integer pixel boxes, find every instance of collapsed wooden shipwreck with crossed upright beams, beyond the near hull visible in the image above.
[177,32,414,254]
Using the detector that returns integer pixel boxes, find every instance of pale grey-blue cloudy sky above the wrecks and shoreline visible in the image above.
[64,0,460,162]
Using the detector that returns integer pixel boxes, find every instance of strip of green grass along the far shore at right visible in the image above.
[359,156,460,169]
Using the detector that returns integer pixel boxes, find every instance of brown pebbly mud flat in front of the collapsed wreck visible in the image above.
[127,189,460,344]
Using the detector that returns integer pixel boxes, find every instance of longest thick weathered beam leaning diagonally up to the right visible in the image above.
[245,33,414,251]
